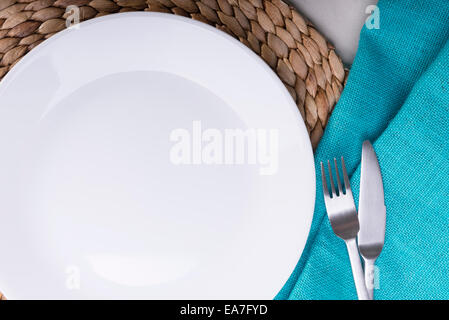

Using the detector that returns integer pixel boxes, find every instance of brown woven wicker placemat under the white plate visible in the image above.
[0,0,346,148]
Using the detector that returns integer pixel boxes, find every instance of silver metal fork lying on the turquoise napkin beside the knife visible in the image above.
[321,157,369,300]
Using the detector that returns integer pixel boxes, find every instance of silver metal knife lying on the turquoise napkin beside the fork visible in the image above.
[358,140,386,299]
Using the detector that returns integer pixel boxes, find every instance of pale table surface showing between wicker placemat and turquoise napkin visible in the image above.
[287,0,382,65]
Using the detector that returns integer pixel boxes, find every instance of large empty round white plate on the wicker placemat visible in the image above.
[0,13,315,299]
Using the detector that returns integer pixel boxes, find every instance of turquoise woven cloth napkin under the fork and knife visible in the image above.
[276,0,449,299]
